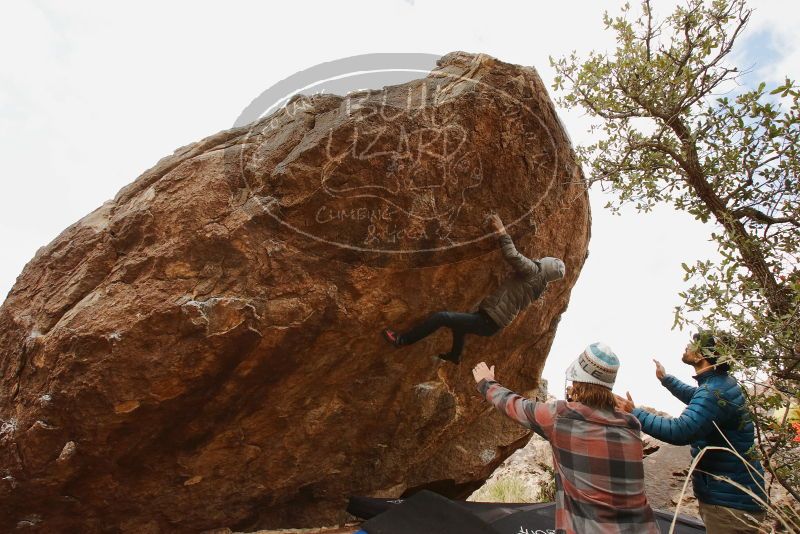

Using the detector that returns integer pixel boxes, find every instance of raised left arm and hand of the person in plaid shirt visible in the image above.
[472,362,555,439]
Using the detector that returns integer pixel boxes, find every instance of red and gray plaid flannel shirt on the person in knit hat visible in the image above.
[478,380,659,534]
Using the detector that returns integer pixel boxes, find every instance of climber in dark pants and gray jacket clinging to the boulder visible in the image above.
[383,215,564,363]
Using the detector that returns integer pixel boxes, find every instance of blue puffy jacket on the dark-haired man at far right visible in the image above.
[633,370,767,512]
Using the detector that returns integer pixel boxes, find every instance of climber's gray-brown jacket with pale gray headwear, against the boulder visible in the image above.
[478,234,564,328]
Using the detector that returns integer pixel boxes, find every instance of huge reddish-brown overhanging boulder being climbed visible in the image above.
[0,52,590,533]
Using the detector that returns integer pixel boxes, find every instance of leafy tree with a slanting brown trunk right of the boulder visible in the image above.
[550,0,800,510]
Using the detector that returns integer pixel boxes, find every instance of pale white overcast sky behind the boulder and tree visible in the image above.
[0,0,800,414]
